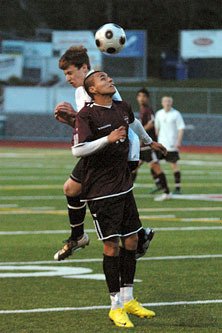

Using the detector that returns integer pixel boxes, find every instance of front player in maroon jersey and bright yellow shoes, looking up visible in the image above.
[72,71,166,327]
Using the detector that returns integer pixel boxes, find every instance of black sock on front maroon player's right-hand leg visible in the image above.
[119,247,136,287]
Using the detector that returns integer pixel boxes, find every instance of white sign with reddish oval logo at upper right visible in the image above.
[180,30,222,59]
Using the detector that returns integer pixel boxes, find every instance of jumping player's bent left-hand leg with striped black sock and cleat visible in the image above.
[54,160,89,260]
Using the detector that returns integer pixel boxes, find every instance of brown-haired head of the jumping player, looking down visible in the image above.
[59,45,90,88]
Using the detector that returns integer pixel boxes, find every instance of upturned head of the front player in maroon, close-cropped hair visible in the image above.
[84,71,116,99]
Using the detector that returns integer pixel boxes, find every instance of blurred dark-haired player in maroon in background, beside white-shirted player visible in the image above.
[134,88,170,198]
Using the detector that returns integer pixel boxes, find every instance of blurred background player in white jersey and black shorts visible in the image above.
[155,96,185,201]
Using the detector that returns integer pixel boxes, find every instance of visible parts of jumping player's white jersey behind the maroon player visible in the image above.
[75,86,140,161]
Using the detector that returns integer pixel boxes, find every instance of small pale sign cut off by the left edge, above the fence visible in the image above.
[0,54,23,81]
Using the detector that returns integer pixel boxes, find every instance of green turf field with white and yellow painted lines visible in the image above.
[0,148,222,333]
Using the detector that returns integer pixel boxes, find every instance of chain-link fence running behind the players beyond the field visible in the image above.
[0,86,222,146]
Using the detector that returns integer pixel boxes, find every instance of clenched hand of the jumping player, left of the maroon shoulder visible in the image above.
[54,102,77,126]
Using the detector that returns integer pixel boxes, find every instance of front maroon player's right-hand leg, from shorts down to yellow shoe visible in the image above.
[119,192,155,318]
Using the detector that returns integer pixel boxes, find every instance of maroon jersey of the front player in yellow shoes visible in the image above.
[74,101,134,200]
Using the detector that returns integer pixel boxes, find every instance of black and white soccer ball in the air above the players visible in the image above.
[95,23,126,54]
